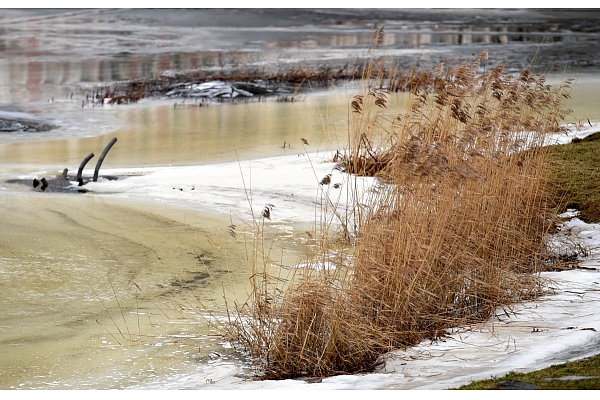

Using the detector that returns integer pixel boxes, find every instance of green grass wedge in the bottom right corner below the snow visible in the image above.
[458,355,600,390]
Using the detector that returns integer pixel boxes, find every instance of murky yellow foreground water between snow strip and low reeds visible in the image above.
[0,192,255,389]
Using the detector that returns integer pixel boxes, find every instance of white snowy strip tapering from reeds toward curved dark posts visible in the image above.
[80,153,374,228]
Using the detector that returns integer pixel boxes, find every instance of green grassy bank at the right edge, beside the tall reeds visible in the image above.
[549,132,600,223]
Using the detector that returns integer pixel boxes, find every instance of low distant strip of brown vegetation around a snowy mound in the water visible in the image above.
[82,27,468,107]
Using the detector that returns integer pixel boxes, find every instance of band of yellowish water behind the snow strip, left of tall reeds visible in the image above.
[0,95,356,167]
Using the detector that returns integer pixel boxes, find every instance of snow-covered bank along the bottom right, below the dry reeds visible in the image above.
[139,214,600,390]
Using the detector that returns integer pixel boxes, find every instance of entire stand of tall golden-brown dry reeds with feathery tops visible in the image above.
[227,43,570,378]
